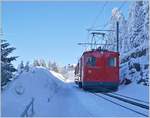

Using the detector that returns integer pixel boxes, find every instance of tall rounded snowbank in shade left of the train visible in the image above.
[2,68,63,117]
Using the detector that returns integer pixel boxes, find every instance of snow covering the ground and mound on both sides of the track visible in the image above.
[2,68,148,117]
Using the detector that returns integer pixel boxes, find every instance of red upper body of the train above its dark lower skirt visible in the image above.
[76,50,119,90]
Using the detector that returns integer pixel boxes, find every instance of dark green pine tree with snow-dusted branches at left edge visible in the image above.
[1,40,17,87]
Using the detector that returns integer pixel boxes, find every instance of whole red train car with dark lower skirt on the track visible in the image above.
[75,48,119,91]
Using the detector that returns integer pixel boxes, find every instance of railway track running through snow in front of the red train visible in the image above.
[90,92,149,117]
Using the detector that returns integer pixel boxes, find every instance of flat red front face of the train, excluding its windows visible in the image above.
[83,51,119,82]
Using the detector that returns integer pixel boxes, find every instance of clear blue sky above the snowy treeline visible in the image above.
[2,1,129,65]
